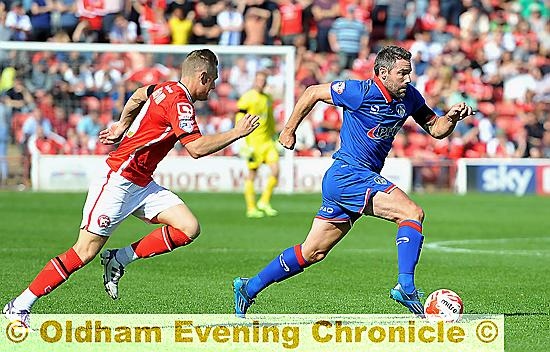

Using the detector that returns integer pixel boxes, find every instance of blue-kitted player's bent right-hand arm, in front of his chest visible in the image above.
[413,102,475,139]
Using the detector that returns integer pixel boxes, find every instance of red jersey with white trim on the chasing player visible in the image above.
[107,82,201,187]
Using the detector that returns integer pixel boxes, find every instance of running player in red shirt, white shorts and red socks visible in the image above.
[3,49,259,327]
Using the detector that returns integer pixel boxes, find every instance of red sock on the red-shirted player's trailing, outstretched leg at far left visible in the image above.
[29,248,83,297]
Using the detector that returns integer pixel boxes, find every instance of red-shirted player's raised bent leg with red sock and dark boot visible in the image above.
[101,186,196,299]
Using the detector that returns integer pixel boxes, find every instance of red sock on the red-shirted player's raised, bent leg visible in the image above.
[132,225,192,258]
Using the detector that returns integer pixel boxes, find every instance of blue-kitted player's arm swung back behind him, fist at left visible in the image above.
[279,83,333,149]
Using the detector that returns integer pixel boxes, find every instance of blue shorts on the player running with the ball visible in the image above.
[315,160,397,223]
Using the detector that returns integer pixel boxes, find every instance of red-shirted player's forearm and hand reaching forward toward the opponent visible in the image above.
[185,114,260,159]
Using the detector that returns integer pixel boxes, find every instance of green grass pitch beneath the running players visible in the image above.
[0,192,550,351]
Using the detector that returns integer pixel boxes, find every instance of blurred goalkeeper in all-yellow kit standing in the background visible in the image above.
[235,71,279,218]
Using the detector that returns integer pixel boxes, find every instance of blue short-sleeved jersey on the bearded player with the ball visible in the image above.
[331,77,425,173]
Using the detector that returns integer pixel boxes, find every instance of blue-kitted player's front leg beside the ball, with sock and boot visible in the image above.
[366,188,424,314]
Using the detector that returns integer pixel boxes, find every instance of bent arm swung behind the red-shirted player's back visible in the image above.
[99,85,155,144]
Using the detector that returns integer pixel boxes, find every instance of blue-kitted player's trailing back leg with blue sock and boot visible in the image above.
[233,218,351,317]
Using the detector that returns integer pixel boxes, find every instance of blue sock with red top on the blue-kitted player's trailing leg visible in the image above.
[246,244,307,298]
